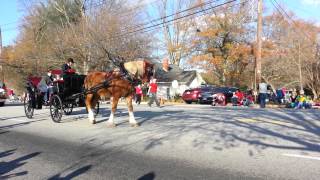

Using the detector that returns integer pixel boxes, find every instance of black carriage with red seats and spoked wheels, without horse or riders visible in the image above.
[24,70,99,122]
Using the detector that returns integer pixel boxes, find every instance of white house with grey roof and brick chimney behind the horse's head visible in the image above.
[155,59,206,99]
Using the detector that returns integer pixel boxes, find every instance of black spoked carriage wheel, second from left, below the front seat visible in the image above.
[50,95,63,123]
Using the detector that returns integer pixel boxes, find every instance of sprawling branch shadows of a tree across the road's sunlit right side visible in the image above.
[109,108,320,156]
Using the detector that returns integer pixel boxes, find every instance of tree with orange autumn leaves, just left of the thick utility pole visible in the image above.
[192,1,252,85]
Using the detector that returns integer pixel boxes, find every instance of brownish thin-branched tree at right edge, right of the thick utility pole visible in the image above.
[262,9,320,98]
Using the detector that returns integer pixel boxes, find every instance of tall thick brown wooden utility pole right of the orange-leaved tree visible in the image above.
[255,0,262,88]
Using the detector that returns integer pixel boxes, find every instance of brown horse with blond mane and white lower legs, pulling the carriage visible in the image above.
[84,60,153,127]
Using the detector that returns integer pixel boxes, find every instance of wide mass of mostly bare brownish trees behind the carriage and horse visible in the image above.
[2,0,150,92]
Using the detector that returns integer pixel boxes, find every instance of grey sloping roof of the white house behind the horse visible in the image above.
[155,63,197,85]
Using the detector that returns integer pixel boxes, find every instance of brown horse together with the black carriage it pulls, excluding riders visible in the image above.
[24,50,154,127]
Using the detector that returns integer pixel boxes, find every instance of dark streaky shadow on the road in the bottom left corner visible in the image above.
[0,149,41,179]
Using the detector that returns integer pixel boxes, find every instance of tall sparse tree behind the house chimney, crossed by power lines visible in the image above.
[157,0,204,66]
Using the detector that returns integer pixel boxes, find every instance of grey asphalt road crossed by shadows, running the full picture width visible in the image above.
[0,102,320,180]
